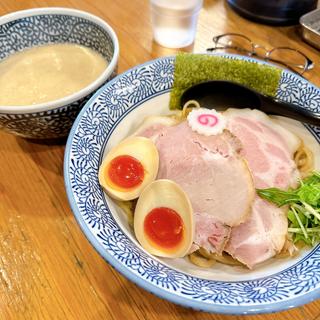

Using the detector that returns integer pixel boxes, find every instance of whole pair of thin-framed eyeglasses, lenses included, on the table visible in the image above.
[207,33,313,75]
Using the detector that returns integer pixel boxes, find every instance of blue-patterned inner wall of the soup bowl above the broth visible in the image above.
[0,13,114,60]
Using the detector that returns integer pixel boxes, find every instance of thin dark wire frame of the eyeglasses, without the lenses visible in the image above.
[207,33,314,75]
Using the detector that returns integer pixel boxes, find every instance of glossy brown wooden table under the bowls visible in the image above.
[0,0,320,320]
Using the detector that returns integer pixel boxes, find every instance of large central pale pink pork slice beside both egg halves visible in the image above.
[150,121,255,253]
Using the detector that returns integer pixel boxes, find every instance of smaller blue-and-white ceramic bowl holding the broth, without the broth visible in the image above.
[0,8,119,139]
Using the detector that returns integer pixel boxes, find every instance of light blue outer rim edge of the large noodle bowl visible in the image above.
[64,53,320,316]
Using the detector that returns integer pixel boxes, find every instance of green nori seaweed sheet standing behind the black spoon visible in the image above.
[170,53,282,110]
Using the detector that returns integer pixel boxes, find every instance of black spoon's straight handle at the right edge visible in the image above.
[260,96,320,126]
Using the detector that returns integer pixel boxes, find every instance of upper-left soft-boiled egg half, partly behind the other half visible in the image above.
[99,137,159,201]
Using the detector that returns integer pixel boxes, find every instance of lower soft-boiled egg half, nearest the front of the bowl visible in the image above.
[134,179,194,258]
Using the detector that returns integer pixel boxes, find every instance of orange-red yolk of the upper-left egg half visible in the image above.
[108,155,144,189]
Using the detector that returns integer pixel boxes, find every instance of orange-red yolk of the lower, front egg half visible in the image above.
[144,207,184,249]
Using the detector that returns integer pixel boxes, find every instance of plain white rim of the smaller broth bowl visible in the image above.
[0,7,120,114]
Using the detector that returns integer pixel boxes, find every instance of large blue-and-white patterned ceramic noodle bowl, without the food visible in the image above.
[64,55,320,314]
